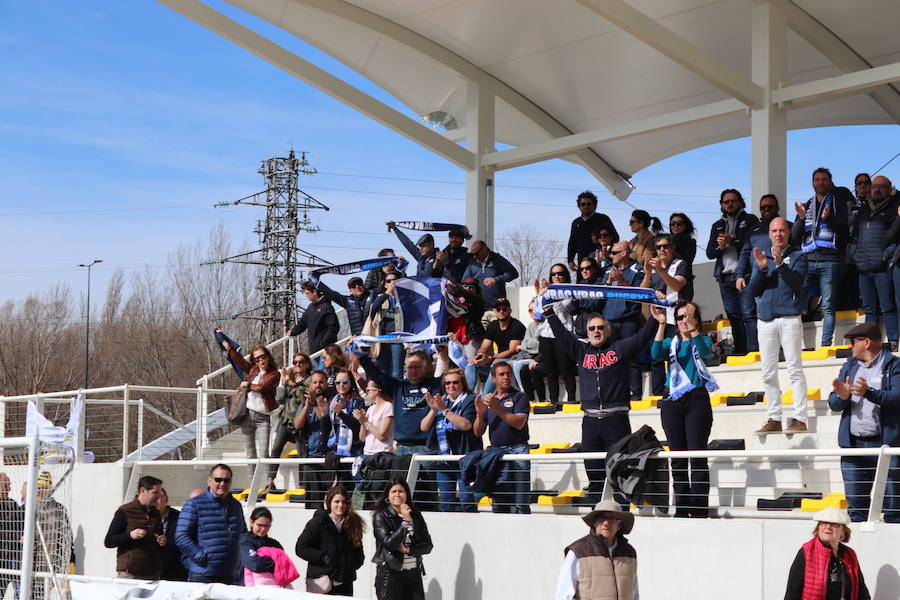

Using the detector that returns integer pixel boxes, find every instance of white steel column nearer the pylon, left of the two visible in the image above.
[466,81,494,246]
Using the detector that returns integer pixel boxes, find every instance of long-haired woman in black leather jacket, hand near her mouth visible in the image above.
[372,478,432,600]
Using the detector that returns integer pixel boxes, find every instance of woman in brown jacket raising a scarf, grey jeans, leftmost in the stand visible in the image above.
[222,341,281,481]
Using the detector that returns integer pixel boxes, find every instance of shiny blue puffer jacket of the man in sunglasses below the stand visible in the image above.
[175,490,247,577]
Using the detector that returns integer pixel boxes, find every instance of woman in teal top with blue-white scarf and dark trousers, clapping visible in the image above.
[650,302,719,518]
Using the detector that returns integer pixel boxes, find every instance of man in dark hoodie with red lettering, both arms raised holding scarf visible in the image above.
[543,304,666,504]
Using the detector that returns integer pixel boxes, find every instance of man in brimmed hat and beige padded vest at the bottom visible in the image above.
[556,500,638,600]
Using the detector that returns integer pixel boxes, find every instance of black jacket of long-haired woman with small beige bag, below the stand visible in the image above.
[294,508,366,583]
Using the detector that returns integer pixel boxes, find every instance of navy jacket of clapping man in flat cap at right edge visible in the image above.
[828,350,900,448]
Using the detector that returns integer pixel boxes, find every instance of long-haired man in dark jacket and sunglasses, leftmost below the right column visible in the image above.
[706,189,759,355]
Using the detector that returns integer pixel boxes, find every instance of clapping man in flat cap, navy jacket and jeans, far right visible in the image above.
[828,323,900,523]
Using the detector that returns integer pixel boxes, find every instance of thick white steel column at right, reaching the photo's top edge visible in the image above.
[750,0,787,216]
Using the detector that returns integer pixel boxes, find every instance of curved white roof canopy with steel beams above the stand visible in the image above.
[158,0,900,220]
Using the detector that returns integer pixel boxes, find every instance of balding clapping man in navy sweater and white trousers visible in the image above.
[747,217,807,433]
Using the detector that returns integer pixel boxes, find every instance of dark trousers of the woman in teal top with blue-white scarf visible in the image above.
[659,387,712,517]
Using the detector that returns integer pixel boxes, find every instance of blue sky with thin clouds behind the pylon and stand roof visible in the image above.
[0,0,900,301]
